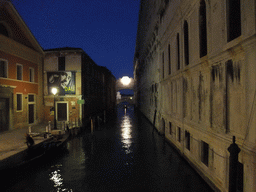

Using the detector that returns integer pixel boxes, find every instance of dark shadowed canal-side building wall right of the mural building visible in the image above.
[83,62,116,126]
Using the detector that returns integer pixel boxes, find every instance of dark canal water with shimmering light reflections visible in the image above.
[3,105,212,192]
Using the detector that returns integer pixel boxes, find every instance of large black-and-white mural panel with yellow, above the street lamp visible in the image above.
[47,72,76,95]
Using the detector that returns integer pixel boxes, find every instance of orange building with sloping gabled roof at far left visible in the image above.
[0,0,44,132]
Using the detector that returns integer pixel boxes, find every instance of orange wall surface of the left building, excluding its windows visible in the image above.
[0,51,43,130]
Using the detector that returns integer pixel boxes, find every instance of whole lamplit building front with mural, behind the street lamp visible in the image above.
[44,48,83,127]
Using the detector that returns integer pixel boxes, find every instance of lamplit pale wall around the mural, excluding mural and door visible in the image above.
[44,50,82,122]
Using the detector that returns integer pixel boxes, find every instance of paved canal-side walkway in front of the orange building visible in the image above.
[0,124,47,164]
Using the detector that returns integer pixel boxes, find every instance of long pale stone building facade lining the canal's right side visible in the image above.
[134,0,256,191]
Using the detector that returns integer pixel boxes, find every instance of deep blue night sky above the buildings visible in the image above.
[12,0,140,79]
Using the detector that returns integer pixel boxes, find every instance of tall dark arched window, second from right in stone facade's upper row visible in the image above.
[199,0,207,57]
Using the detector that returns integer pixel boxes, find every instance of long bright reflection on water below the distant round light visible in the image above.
[121,115,132,154]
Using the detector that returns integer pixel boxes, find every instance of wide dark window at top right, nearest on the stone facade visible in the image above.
[227,0,241,42]
